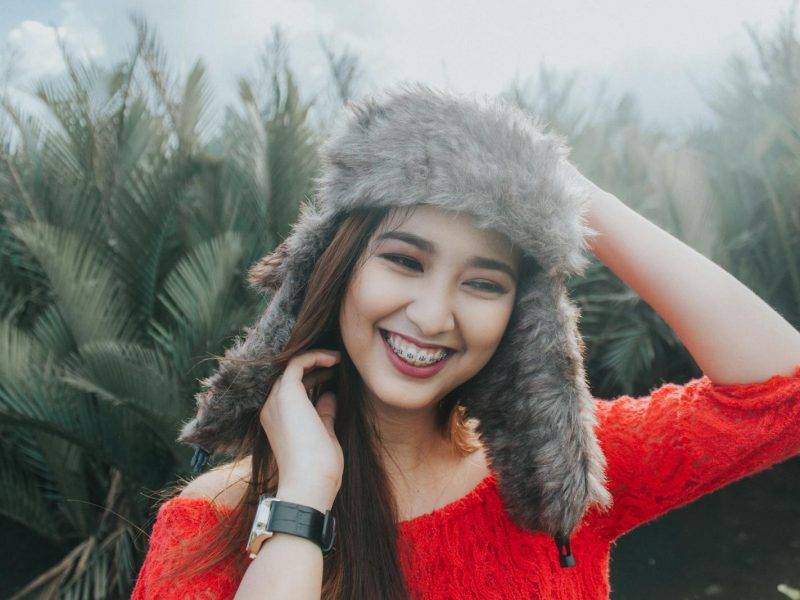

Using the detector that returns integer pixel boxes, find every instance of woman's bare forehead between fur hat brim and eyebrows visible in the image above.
[375,204,518,260]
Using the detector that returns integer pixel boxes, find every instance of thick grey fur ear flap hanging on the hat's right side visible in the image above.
[464,270,611,537]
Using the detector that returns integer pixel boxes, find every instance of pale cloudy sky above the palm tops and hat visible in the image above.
[0,0,800,132]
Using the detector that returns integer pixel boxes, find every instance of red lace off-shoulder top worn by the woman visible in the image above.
[132,366,800,600]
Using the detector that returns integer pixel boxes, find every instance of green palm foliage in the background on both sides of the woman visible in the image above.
[0,5,800,598]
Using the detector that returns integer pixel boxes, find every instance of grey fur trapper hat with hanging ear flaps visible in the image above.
[178,83,611,566]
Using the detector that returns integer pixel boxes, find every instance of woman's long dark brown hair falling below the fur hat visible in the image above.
[143,208,480,600]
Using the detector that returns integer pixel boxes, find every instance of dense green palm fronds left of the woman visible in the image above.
[0,15,346,597]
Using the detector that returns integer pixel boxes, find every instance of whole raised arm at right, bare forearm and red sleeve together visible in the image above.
[567,163,800,539]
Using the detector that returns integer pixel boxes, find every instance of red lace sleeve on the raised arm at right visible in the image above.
[590,364,800,540]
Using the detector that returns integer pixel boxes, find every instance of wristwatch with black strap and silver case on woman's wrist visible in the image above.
[246,494,336,558]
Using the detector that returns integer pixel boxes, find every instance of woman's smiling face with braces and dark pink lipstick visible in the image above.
[339,205,519,409]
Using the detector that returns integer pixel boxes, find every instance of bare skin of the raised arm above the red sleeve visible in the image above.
[570,166,800,384]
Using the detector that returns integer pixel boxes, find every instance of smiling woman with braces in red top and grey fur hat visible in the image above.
[133,82,800,599]
